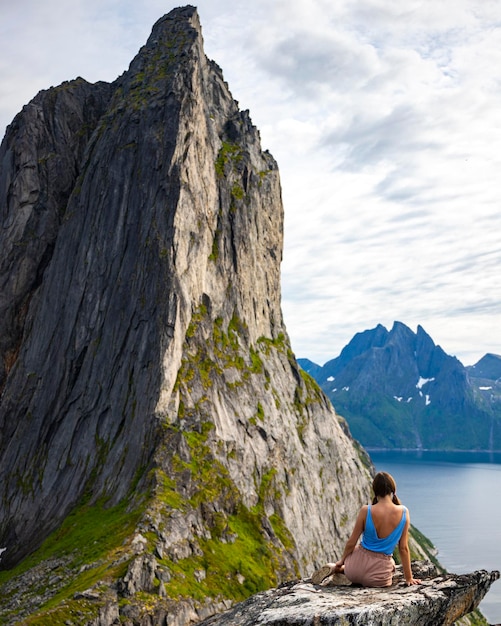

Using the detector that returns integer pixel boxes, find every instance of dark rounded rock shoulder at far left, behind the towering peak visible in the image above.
[0,79,112,390]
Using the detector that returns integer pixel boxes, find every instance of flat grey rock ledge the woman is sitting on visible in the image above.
[200,563,499,626]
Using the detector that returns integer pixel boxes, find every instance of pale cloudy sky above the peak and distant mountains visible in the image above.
[0,0,501,365]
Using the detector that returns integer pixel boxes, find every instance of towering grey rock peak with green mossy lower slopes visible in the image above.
[0,7,371,624]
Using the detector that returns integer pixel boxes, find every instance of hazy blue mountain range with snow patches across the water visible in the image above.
[298,322,501,451]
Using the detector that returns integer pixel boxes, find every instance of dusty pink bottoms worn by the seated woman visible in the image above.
[344,544,395,587]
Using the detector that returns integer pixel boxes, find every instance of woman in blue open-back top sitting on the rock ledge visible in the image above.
[311,472,421,587]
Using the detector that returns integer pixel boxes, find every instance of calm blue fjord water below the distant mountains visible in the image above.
[370,451,501,624]
